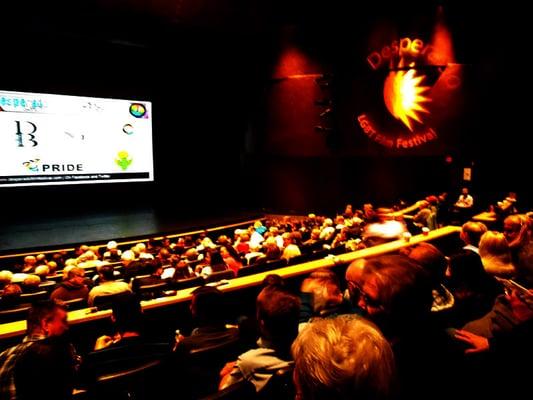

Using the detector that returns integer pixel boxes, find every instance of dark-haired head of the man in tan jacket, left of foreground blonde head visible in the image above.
[256,286,300,352]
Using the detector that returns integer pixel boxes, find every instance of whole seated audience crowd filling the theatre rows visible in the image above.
[0,198,533,400]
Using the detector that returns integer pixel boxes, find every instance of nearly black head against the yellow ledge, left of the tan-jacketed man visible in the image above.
[190,286,225,326]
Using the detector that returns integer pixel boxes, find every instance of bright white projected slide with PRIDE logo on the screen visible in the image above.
[0,91,154,187]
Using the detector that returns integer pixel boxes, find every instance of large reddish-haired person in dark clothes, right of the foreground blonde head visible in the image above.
[359,255,462,399]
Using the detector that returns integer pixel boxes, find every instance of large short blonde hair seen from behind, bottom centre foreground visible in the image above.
[292,315,394,400]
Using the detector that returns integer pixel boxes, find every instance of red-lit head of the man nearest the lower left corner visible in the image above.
[27,300,68,337]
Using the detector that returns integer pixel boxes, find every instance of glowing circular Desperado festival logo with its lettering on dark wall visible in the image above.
[356,38,460,148]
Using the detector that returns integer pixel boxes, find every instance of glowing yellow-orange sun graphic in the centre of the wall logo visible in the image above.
[383,62,431,132]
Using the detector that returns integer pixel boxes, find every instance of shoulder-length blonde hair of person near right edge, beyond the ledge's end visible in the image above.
[479,231,515,277]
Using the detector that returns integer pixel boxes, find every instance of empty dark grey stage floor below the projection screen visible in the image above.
[0,209,262,254]
